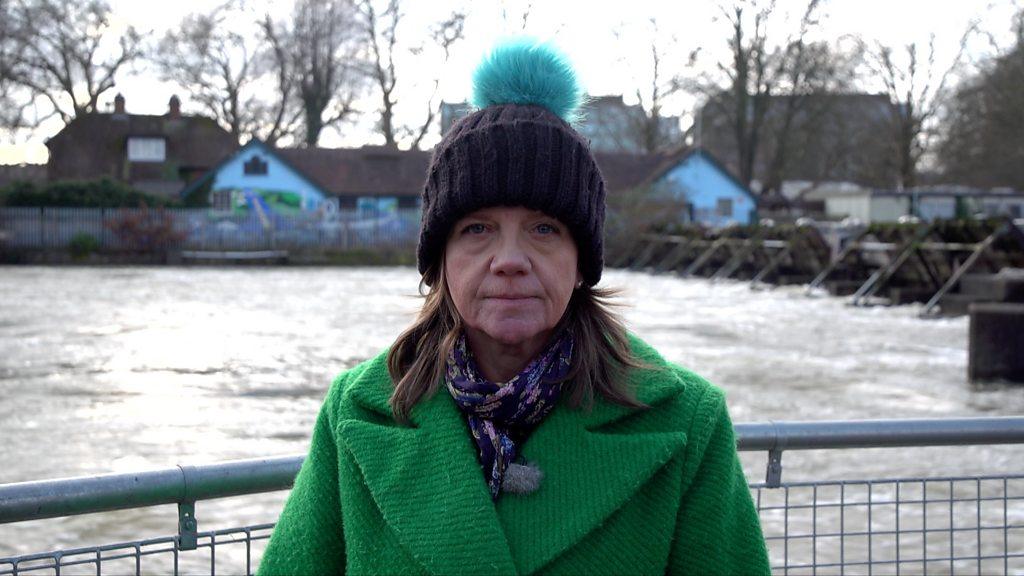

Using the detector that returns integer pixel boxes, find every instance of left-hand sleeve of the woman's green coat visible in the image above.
[258,378,345,576]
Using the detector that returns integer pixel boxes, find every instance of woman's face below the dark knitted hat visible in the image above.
[444,206,580,349]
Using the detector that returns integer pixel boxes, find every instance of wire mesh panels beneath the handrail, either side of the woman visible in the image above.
[0,476,1024,576]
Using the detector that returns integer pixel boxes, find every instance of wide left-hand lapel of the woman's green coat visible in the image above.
[338,362,516,574]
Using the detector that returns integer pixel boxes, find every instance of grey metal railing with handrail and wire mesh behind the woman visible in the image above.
[0,417,1024,576]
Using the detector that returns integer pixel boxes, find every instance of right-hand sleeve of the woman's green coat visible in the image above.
[668,386,770,575]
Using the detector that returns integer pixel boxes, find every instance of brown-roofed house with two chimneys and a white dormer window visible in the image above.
[46,94,239,196]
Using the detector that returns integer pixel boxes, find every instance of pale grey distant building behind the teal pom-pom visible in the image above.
[441,95,684,154]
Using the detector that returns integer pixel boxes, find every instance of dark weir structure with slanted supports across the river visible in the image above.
[608,218,1024,317]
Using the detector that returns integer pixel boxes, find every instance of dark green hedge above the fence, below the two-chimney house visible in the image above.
[0,178,178,208]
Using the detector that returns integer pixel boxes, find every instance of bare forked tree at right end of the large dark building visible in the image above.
[870,23,977,188]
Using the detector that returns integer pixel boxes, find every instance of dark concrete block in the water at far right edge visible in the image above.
[968,302,1024,383]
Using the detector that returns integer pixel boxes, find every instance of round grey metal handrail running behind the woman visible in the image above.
[0,416,1024,524]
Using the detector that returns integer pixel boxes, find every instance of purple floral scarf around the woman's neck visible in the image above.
[445,332,572,500]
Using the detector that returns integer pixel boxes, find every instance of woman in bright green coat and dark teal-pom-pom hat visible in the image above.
[260,40,768,574]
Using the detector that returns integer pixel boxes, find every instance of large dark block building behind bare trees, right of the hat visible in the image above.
[694,93,898,187]
